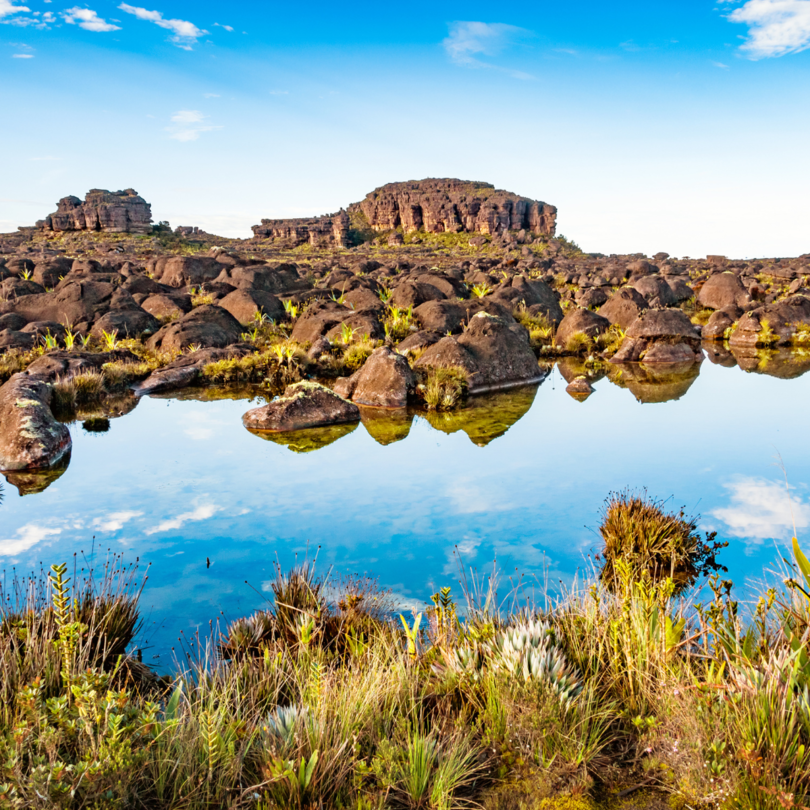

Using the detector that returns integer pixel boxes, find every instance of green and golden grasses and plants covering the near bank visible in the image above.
[0,497,810,810]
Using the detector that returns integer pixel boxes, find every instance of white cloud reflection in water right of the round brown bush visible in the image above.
[709,478,810,540]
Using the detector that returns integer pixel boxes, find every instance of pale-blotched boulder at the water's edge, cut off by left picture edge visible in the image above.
[0,373,71,470]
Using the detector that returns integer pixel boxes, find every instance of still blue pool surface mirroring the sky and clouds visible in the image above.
[0,362,810,664]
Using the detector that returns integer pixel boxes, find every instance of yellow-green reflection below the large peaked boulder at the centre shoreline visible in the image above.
[424,382,548,447]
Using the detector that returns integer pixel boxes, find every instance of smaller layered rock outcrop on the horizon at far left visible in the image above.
[37,188,152,233]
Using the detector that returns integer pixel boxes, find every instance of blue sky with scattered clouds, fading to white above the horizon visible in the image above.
[0,0,810,257]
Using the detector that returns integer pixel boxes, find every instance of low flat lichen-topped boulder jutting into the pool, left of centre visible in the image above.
[242,382,360,432]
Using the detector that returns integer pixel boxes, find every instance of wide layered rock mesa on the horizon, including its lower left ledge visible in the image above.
[252,178,557,247]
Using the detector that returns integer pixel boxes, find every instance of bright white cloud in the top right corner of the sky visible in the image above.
[729,0,810,59]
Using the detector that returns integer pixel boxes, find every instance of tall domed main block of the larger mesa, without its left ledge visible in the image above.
[349,178,557,236]
